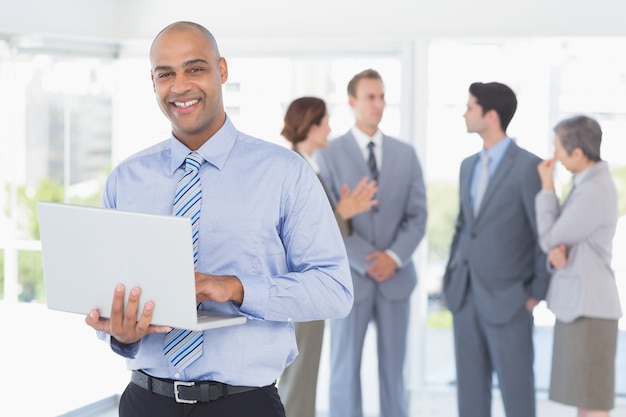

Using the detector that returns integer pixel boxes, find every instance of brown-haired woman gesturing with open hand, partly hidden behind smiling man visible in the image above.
[278,97,376,417]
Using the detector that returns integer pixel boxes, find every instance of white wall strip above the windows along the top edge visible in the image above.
[0,0,626,42]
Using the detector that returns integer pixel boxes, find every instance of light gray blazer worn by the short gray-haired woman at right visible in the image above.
[535,161,622,323]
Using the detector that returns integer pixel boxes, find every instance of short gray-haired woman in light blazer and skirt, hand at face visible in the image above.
[535,115,622,417]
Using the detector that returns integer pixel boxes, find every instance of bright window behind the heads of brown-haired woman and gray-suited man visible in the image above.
[224,56,401,146]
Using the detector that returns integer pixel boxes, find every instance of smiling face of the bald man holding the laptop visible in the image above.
[150,28,228,144]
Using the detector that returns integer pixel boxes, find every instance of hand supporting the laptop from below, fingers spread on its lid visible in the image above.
[85,284,172,344]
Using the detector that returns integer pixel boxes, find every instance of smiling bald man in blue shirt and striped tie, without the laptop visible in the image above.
[85,22,353,417]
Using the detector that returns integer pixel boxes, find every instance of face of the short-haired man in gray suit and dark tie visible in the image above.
[349,78,385,132]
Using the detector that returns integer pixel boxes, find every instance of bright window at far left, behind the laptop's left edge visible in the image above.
[0,54,113,302]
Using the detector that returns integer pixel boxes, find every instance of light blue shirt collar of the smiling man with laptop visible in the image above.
[170,116,237,174]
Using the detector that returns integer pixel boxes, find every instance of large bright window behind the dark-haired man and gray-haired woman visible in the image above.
[423,38,626,395]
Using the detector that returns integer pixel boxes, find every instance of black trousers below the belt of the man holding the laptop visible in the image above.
[119,383,285,417]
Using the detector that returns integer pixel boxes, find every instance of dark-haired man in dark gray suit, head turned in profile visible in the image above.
[444,82,549,417]
